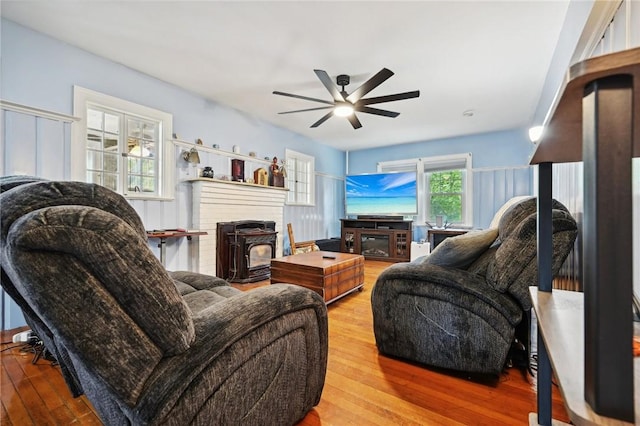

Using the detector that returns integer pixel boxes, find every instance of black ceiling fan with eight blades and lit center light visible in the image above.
[273,68,420,129]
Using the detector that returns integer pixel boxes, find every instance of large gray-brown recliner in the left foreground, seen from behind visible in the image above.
[0,177,327,425]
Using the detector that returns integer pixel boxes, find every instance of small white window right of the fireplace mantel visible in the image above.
[284,149,316,206]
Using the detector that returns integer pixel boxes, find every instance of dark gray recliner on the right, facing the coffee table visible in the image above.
[371,197,577,375]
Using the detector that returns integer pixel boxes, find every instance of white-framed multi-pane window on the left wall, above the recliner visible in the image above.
[72,87,174,199]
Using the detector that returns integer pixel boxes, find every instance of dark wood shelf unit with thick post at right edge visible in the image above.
[530,48,640,425]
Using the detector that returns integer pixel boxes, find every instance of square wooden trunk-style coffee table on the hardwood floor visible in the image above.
[271,251,364,304]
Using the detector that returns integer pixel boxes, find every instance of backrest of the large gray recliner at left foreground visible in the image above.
[0,182,195,405]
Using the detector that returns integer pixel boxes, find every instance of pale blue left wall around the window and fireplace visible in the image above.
[0,19,345,329]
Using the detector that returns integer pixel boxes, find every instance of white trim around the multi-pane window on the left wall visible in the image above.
[69,86,175,200]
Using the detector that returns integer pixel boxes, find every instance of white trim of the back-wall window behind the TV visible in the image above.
[377,152,473,228]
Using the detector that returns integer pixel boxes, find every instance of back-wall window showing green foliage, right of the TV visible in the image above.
[378,153,473,226]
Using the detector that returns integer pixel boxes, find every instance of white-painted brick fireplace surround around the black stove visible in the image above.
[190,178,287,275]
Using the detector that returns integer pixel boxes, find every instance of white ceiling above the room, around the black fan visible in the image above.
[1,0,573,150]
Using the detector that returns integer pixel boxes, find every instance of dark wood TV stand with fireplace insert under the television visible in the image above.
[340,217,413,262]
